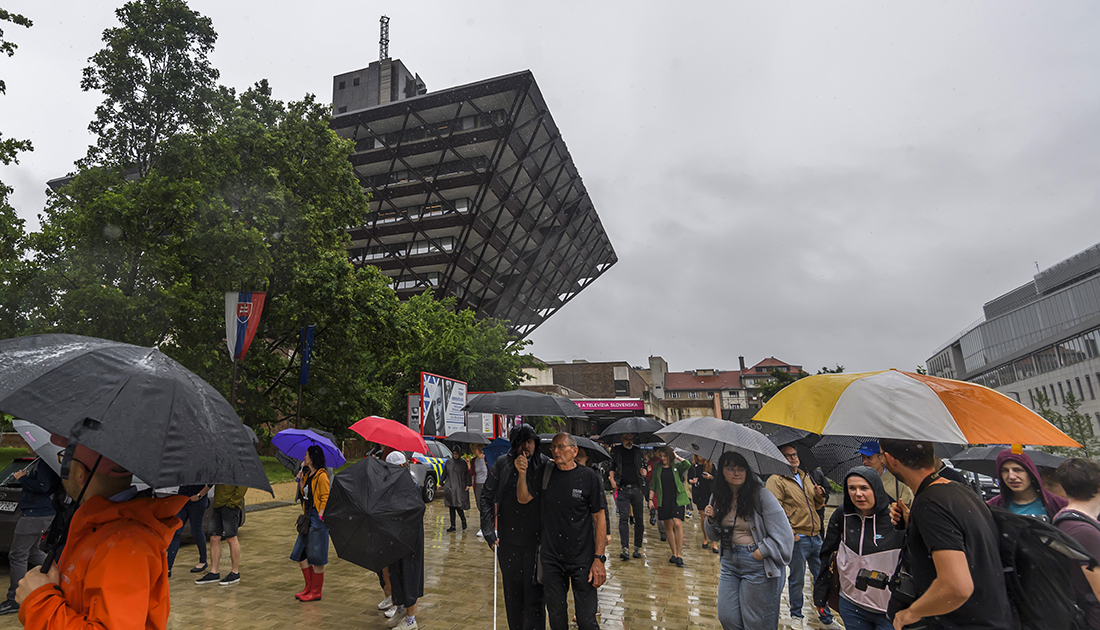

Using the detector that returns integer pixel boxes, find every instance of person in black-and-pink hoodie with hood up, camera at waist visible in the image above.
[814,466,905,630]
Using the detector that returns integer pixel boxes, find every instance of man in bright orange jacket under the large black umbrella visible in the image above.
[15,435,187,630]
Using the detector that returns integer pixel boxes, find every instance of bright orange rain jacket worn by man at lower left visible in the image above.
[19,496,188,630]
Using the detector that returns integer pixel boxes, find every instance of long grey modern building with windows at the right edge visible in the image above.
[927,244,1100,430]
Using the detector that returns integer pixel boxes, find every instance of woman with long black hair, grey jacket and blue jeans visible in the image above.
[703,452,794,630]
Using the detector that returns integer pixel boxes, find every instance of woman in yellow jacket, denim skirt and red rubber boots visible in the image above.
[290,444,330,601]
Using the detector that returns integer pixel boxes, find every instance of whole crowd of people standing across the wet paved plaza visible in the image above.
[0,424,1100,630]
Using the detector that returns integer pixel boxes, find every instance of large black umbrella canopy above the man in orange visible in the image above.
[0,334,271,491]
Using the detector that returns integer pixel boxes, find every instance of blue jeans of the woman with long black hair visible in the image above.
[718,544,783,630]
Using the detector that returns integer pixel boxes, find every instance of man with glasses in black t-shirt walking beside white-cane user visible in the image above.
[516,433,607,630]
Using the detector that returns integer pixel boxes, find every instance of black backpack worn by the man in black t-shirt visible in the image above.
[990,507,1097,630]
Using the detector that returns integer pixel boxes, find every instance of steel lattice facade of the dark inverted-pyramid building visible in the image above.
[331,71,617,336]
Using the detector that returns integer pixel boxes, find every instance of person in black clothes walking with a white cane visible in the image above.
[477,424,548,630]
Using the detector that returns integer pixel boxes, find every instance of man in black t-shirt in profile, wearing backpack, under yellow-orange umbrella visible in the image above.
[880,440,1013,630]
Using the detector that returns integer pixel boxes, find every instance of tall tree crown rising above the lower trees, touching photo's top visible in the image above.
[79,0,218,176]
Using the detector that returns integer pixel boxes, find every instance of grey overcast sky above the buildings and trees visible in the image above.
[0,0,1100,372]
